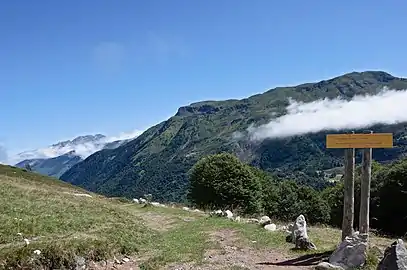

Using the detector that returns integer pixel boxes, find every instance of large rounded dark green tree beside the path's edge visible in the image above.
[188,153,262,214]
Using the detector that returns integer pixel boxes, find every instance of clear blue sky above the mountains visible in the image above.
[0,0,407,157]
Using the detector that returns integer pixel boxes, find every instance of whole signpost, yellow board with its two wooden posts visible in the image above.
[326,131,393,240]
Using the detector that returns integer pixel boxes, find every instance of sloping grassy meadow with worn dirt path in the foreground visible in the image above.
[0,165,392,269]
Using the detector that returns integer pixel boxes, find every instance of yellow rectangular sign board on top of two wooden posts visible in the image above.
[326,133,393,148]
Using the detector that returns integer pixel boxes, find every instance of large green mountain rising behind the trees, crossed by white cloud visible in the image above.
[61,71,407,201]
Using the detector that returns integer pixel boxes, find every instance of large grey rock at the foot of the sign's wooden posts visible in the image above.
[329,232,368,269]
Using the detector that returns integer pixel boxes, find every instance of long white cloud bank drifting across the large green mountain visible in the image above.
[247,89,407,141]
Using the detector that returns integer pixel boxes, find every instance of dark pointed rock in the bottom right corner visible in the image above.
[377,239,407,270]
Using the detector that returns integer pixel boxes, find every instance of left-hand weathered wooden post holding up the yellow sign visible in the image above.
[342,148,355,240]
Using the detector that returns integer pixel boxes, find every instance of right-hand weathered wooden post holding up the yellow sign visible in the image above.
[359,131,373,233]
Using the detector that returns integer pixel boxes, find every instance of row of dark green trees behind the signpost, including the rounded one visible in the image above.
[187,153,407,236]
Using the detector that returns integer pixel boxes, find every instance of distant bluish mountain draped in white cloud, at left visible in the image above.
[15,134,131,178]
